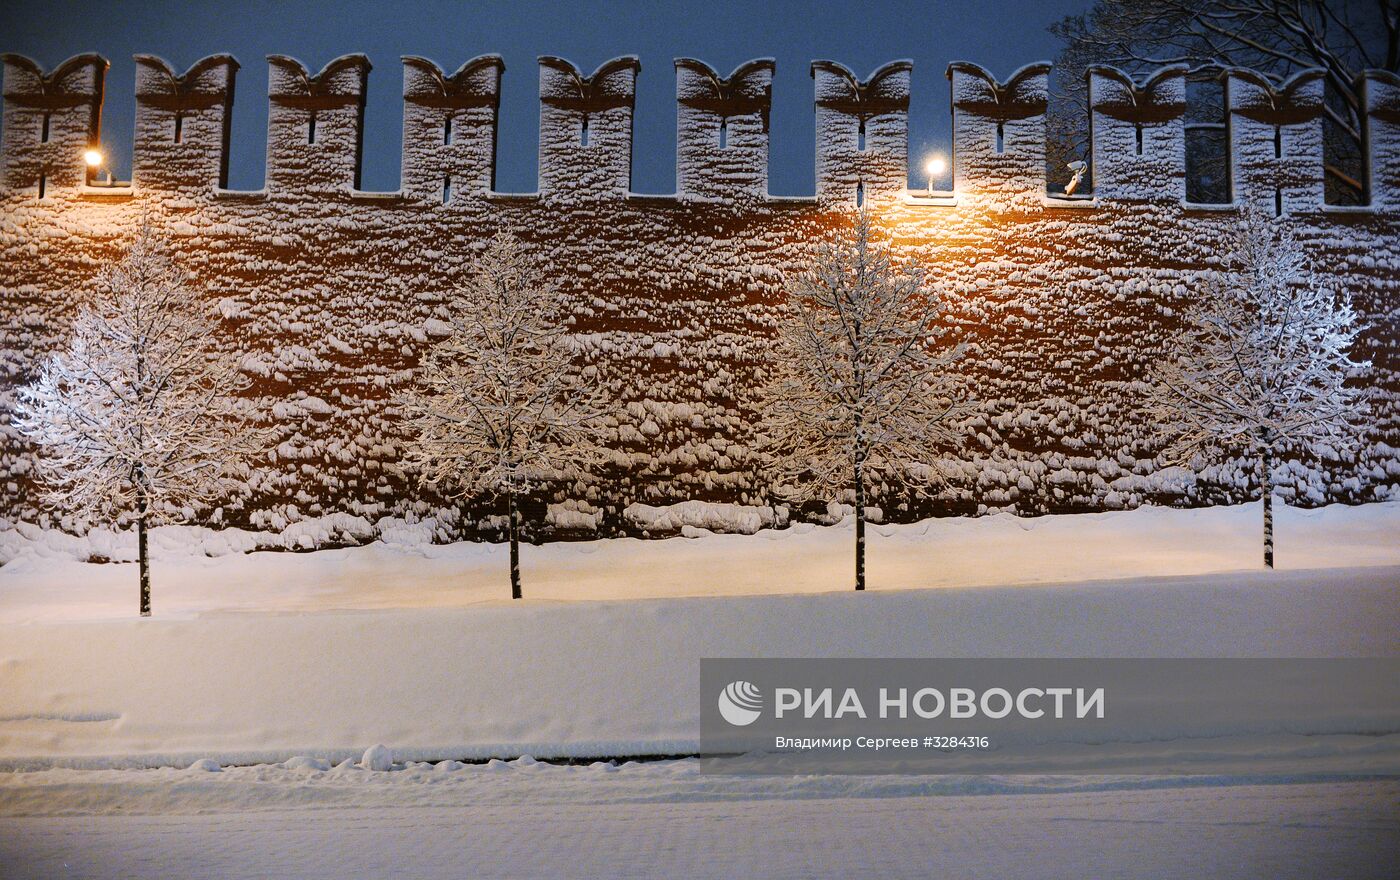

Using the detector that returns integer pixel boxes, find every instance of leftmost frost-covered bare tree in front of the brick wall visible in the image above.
[15,225,266,617]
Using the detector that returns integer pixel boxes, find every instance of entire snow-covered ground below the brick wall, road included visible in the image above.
[0,504,1400,879]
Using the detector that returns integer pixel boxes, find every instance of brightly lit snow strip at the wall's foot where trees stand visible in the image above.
[0,502,1400,624]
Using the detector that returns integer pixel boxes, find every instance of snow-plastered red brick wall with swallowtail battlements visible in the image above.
[0,55,1400,533]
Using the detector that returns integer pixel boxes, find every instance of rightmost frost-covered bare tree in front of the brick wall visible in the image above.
[1147,210,1369,568]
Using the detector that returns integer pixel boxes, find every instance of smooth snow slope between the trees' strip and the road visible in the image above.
[0,567,1400,767]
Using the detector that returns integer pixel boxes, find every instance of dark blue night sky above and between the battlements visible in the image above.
[0,0,1088,194]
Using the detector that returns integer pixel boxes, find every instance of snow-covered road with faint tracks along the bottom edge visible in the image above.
[0,761,1400,880]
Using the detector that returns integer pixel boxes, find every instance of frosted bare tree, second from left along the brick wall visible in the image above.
[400,232,608,599]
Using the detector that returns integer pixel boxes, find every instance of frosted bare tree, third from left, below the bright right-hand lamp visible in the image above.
[757,210,970,590]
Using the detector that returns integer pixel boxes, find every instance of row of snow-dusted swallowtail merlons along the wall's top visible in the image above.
[8,55,1400,213]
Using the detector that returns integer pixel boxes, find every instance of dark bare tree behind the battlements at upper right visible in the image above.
[1047,0,1400,204]
